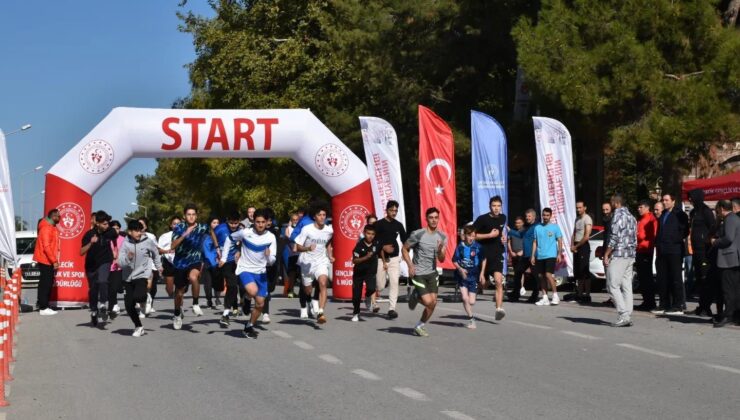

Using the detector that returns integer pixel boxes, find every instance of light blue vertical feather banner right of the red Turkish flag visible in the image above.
[470,111,509,223]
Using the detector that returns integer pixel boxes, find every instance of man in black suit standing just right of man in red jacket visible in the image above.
[652,194,689,315]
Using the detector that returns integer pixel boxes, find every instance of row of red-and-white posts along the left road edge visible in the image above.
[0,267,21,407]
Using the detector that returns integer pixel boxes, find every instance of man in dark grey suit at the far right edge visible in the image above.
[713,200,740,328]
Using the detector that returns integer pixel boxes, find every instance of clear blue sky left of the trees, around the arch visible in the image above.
[0,0,213,230]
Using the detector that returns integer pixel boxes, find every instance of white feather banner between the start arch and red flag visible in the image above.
[360,117,406,226]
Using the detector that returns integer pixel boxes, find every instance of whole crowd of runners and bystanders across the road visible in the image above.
[28,190,740,339]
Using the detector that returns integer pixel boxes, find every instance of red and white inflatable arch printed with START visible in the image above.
[44,108,373,307]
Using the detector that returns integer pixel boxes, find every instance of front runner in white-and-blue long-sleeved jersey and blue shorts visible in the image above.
[221,209,277,339]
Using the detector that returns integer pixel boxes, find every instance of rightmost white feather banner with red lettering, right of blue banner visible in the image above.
[532,117,576,276]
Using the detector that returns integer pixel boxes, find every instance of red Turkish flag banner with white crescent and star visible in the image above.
[419,105,457,269]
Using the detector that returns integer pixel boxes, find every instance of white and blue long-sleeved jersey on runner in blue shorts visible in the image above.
[221,228,277,275]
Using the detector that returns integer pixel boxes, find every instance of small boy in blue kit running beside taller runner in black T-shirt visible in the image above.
[452,226,486,329]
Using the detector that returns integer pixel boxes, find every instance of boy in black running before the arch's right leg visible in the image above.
[352,224,379,322]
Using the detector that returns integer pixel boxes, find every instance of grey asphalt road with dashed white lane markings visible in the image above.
[0,286,740,420]
